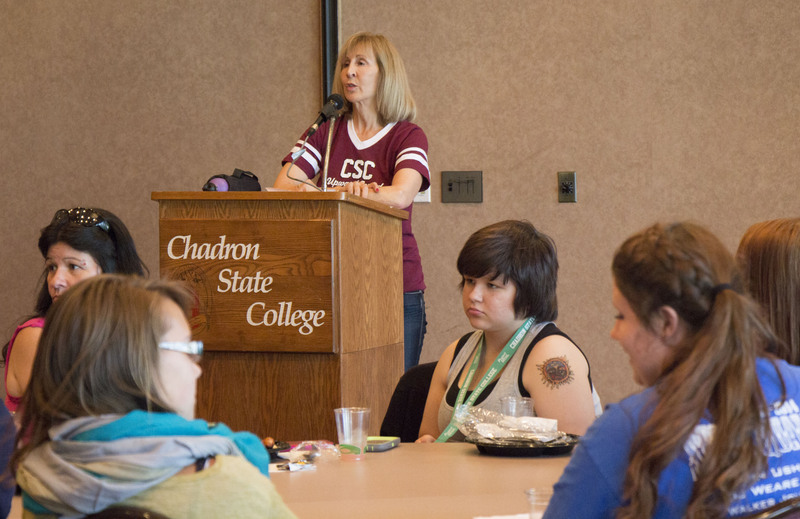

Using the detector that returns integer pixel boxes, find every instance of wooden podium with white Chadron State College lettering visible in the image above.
[152,192,408,442]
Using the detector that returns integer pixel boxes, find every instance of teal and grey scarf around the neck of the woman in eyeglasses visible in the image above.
[17,411,269,517]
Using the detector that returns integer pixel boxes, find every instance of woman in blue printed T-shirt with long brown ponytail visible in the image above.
[544,223,800,519]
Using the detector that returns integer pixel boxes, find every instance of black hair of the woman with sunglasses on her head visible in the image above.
[35,208,149,317]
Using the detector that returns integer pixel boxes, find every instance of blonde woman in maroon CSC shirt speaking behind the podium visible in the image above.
[274,32,430,369]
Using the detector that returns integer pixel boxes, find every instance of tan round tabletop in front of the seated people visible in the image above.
[271,443,569,519]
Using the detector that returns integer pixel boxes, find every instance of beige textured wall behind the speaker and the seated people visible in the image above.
[0,0,800,410]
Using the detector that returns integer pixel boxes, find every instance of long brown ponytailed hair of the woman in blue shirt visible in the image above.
[612,223,774,519]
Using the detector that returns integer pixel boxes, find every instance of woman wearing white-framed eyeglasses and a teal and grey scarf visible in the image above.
[11,275,294,519]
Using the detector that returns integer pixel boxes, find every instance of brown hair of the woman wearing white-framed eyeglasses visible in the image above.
[11,274,193,467]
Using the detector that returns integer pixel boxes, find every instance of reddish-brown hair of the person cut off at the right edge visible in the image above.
[736,218,800,365]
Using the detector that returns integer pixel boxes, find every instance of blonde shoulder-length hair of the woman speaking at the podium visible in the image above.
[332,32,417,125]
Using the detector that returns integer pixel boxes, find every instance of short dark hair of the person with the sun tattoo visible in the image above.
[456,220,558,321]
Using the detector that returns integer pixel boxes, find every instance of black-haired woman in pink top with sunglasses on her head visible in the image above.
[4,207,147,413]
